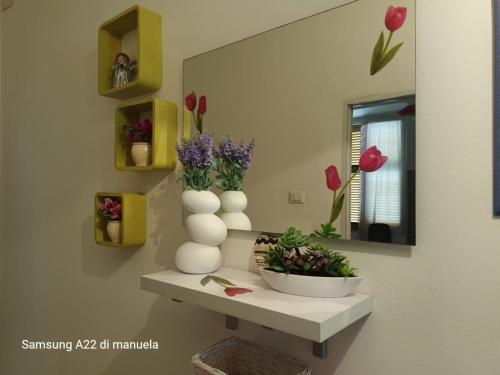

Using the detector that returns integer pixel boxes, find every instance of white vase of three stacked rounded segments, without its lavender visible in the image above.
[175,190,227,274]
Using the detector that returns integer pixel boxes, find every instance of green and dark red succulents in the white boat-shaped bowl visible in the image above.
[265,228,356,277]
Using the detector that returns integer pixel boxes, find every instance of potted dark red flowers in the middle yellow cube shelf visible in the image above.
[123,118,153,167]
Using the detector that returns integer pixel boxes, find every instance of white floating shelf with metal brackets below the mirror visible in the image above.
[141,267,373,357]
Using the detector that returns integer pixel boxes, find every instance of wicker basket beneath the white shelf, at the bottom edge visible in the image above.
[191,337,311,375]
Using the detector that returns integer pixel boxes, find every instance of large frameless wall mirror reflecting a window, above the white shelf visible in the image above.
[184,0,416,245]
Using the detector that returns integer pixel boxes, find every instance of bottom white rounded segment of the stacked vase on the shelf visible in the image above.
[175,242,222,274]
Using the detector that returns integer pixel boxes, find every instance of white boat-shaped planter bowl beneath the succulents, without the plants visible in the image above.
[259,268,363,298]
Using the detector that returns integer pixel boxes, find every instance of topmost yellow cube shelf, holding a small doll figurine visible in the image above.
[98,5,163,99]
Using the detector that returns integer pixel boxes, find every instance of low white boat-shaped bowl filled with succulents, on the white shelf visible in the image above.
[260,227,362,297]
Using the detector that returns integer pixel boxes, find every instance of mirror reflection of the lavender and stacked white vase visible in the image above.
[214,137,255,230]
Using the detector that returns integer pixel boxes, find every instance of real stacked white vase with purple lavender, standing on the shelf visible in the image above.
[175,134,227,274]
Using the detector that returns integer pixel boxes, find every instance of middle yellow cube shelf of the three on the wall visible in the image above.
[115,98,177,171]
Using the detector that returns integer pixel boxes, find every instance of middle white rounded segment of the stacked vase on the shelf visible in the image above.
[186,214,227,246]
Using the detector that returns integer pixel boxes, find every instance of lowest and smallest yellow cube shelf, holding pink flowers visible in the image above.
[94,193,147,247]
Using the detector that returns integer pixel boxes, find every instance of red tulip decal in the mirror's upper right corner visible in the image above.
[370,5,408,75]
